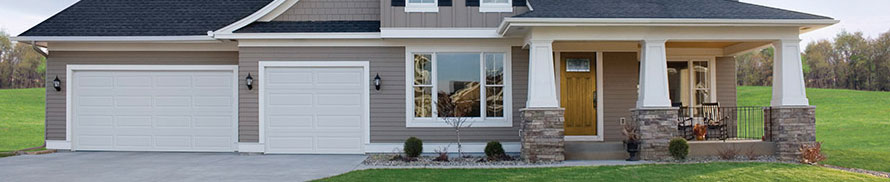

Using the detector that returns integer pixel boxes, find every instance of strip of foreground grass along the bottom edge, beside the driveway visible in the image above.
[318,163,890,182]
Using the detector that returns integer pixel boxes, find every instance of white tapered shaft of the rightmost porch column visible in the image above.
[771,39,810,106]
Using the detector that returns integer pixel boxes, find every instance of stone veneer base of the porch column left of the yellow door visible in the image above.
[519,108,565,162]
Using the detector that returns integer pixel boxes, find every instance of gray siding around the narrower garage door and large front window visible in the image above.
[239,47,528,143]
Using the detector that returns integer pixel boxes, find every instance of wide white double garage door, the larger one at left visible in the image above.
[71,67,237,151]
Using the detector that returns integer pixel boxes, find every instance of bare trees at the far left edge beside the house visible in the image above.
[0,31,46,89]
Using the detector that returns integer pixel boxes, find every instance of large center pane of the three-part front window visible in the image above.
[436,53,482,117]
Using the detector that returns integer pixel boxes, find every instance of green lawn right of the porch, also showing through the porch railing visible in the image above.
[738,87,890,172]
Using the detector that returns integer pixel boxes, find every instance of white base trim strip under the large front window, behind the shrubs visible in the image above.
[365,142,521,153]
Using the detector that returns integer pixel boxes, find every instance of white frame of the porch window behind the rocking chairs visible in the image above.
[668,57,718,107]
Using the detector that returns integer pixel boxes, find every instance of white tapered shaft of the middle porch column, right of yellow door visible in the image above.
[637,40,671,108]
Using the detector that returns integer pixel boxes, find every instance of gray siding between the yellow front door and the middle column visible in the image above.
[603,52,640,141]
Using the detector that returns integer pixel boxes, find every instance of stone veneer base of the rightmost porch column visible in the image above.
[769,106,816,161]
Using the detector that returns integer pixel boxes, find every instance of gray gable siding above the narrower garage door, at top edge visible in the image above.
[273,0,380,21]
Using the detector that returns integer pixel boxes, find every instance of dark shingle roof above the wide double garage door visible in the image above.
[19,0,272,36]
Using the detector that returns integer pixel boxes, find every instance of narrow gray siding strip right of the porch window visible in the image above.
[716,57,738,107]
